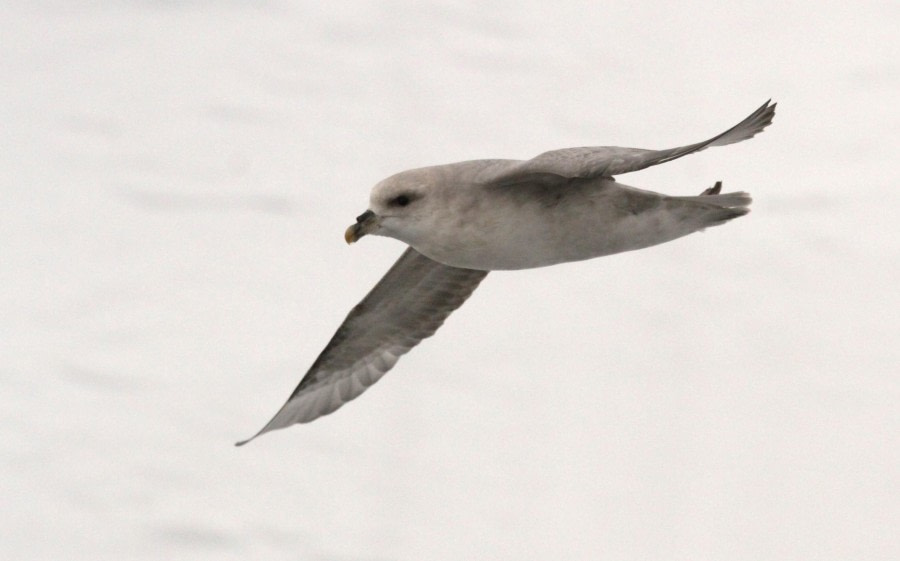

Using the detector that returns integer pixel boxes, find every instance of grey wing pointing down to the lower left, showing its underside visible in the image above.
[237,247,488,446]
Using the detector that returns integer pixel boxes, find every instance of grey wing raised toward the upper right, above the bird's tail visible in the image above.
[490,100,777,185]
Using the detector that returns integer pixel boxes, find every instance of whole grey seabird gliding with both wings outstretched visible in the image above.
[237,100,775,446]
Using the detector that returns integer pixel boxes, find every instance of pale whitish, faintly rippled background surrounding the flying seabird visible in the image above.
[0,0,900,561]
